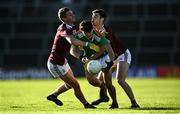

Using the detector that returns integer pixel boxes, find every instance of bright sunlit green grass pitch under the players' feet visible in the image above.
[0,78,180,114]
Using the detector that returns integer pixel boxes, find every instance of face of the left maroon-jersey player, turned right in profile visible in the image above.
[65,10,76,23]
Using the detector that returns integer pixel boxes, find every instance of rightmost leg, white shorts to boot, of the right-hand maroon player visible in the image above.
[116,50,139,108]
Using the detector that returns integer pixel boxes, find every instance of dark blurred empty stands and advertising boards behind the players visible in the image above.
[0,0,180,79]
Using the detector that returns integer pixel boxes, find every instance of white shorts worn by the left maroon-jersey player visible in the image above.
[47,59,70,78]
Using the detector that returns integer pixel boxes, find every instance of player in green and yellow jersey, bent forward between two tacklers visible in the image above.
[70,21,118,109]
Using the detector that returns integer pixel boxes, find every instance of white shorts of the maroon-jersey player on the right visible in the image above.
[115,49,131,64]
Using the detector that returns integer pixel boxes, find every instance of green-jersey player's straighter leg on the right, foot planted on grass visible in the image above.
[104,70,119,109]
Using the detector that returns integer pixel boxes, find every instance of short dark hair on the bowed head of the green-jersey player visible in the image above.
[79,20,93,33]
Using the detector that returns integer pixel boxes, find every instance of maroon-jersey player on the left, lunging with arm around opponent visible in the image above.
[47,7,95,108]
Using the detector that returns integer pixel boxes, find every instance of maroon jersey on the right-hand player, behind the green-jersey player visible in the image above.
[100,26,127,58]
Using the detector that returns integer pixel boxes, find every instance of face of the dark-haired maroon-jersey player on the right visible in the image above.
[91,13,101,26]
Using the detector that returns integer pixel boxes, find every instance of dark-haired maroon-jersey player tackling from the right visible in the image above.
[92,9,139,108]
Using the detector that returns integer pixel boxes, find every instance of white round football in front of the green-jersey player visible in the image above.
[87,60,102,74]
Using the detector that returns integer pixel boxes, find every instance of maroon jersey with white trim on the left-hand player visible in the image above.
[49,23,78,65]
